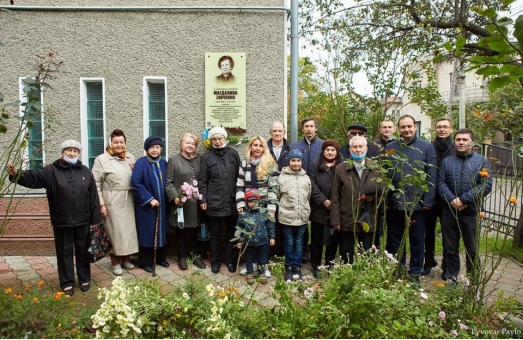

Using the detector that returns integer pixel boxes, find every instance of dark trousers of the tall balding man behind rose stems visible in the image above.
[387,209,426,274]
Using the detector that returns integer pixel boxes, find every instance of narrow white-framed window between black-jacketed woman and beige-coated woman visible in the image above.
[80,79,105,169]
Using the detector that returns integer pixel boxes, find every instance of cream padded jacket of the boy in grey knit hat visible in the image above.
[278,166,312,226]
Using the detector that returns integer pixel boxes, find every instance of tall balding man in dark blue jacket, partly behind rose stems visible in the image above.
[387,115,437,282]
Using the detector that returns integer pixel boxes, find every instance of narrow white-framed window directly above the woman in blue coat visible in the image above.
[143,78,168,158]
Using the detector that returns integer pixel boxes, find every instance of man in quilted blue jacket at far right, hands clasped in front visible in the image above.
[438,129,492,281]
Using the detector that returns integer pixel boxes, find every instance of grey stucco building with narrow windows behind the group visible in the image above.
[0,0,289,255]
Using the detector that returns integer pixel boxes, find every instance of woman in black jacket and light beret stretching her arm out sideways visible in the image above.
[7,139,102,295]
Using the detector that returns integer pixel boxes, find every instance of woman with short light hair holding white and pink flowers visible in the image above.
[165,132,205,270]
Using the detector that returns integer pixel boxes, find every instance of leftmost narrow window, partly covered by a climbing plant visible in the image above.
[19,77,44,169]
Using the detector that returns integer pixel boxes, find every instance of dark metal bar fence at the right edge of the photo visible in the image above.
[483,144,523,236]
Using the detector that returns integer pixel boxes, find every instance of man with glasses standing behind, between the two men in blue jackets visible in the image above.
[421,117,456,275]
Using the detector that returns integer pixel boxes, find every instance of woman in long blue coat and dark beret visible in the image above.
[131,136,169,273]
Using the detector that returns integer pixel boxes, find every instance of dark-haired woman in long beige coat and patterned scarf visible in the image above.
[92,129,138,275]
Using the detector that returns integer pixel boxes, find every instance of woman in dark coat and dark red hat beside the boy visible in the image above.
[310,139,342,278]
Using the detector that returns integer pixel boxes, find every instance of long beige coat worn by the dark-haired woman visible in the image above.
[92,152,138,256]
